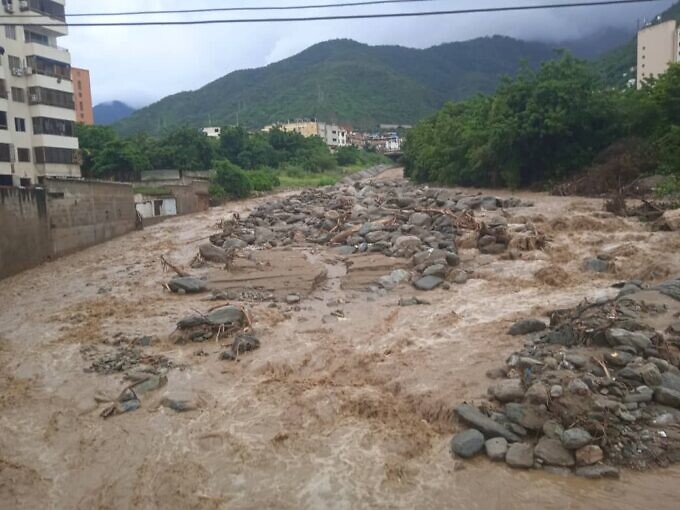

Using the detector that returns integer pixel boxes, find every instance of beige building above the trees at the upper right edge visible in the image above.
[637,20,680,88]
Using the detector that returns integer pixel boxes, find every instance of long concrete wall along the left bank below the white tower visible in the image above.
[0,178,137,278]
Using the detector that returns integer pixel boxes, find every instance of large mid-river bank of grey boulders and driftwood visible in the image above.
[205,180,545,290]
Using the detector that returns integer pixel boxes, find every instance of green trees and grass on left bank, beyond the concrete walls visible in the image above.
[77,124,385,198]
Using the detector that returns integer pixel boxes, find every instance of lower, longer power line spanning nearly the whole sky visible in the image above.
[4,0,662,27]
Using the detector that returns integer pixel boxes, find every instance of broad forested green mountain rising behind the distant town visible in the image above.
[114,36,554,135]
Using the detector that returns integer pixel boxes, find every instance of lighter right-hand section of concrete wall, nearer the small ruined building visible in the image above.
[45,179,136,256]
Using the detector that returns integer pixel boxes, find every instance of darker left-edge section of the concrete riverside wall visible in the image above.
[0,188,51,279]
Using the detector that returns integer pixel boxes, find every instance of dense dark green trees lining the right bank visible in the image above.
[404,54,680,191]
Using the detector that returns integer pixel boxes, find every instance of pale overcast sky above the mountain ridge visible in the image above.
[60,0,673,107]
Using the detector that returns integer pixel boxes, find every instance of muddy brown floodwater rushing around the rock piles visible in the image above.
[0,171,680,510]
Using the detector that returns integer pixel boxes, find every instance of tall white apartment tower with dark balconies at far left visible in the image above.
[0,0,81,186]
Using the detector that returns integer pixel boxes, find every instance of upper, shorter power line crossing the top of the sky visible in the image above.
[0,0,456,18]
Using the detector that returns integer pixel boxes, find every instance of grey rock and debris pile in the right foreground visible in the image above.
[451,278,680,478]
